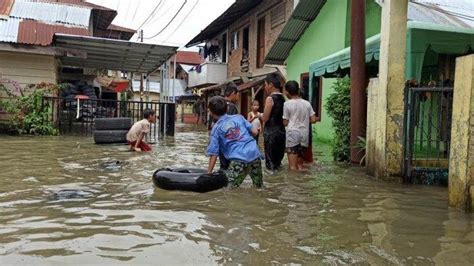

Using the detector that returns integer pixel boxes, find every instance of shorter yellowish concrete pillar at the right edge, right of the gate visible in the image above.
[449,55,474,211]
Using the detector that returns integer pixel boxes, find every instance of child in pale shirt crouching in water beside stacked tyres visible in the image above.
[127,110,156,151]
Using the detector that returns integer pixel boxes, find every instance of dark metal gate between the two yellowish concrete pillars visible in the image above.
[404,87,453,186]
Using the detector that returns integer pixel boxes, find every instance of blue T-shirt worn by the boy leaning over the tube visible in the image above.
[207,115,262,163]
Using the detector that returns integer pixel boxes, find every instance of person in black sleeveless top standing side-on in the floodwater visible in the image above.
[262,74,286,170]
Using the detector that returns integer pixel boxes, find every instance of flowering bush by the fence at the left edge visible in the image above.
[0,83,58,135]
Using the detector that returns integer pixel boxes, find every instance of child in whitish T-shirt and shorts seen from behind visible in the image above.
[283,80,316,171]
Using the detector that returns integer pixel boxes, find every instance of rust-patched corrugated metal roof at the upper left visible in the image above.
[0,0,130,46]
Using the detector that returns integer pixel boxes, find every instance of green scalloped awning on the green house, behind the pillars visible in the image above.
[309,21,474,80]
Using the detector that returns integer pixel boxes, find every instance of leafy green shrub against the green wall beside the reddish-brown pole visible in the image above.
[325,77,351,162]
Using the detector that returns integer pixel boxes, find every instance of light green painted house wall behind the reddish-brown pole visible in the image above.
[287,0,382,141]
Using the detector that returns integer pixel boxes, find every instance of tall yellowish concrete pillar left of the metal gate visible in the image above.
[367,0,408,181]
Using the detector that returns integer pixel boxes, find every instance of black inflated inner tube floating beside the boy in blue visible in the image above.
[153,168,228,193]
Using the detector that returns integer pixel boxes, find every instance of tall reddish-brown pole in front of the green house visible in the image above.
[350,0,367,163]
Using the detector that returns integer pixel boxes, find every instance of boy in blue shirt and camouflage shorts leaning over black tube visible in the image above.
[207,96,263,188]
